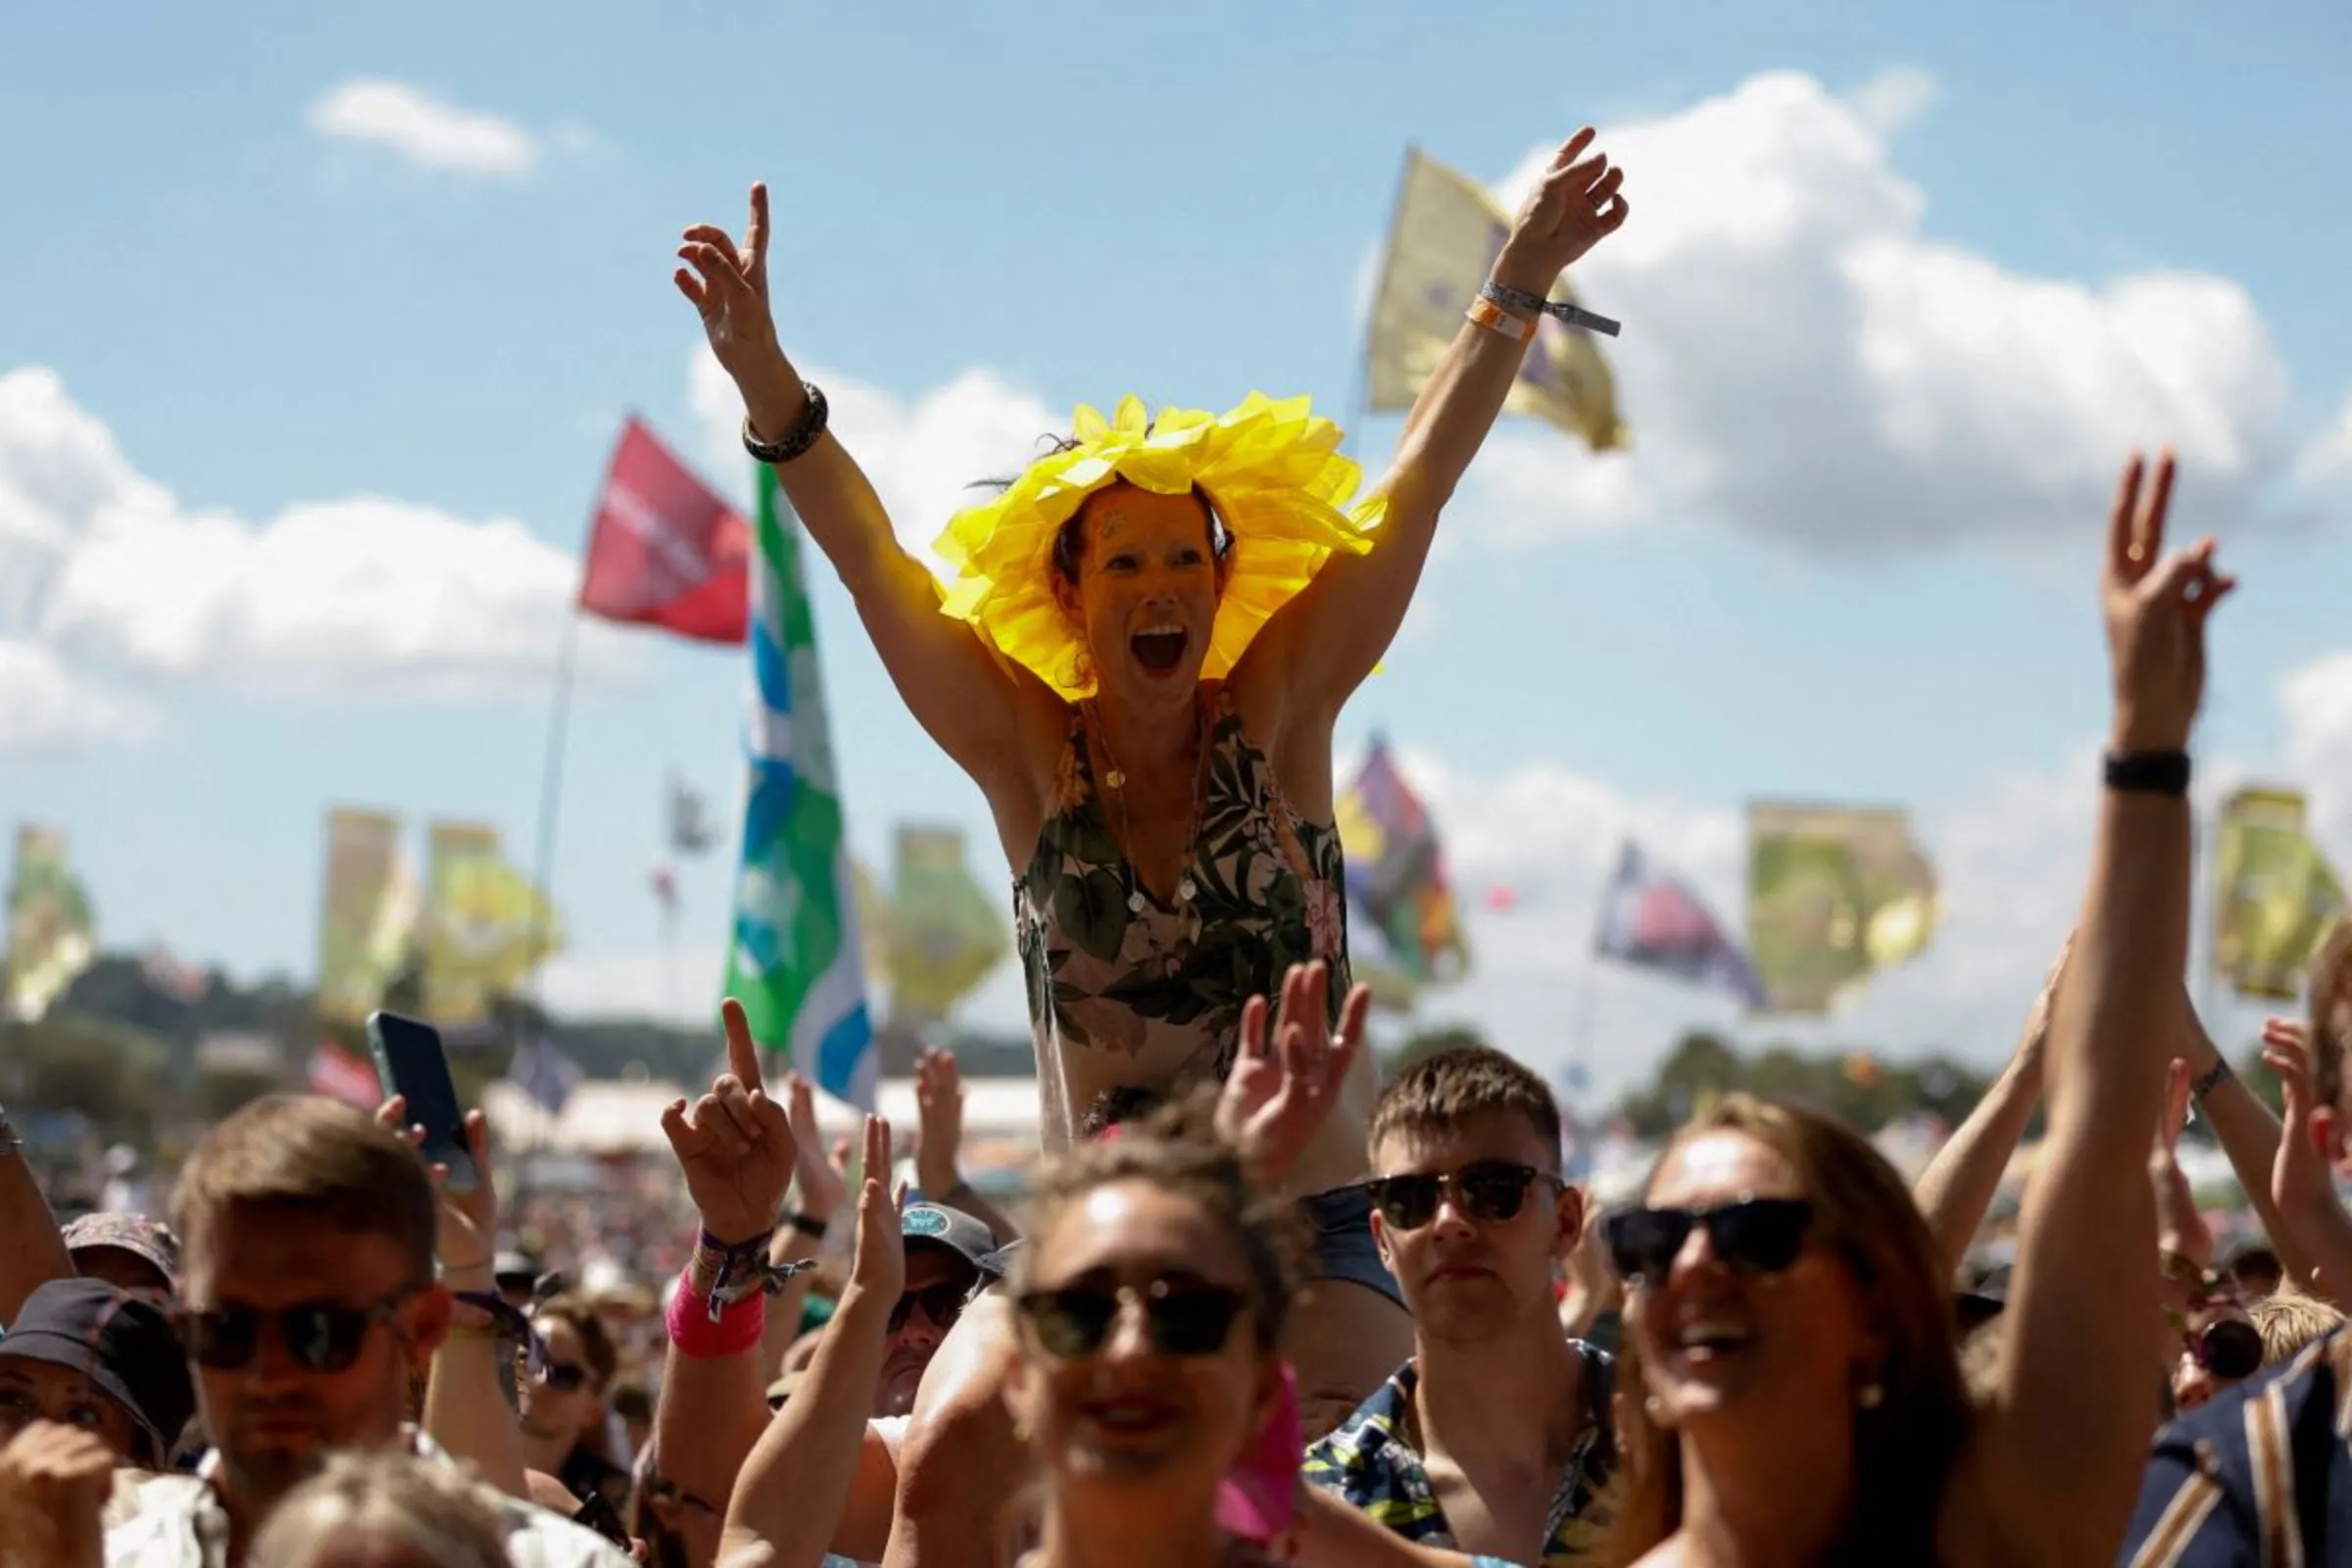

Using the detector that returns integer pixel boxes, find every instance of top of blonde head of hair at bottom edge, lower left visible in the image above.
[247,1452,513,1568]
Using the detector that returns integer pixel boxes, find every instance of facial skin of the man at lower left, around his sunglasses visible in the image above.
[183,1206,449,1533]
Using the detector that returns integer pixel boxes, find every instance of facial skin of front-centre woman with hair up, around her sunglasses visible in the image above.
[1009,1180,1277,1561]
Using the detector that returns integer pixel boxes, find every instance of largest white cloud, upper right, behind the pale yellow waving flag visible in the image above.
[1475,73,2286,553]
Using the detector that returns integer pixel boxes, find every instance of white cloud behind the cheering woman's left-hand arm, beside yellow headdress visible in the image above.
[687,346,1070,576]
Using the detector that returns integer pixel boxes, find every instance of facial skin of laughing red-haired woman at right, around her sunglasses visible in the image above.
[1625,1131,1884,1441]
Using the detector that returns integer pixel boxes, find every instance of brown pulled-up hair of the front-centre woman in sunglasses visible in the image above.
[1011,1086,1298,1349]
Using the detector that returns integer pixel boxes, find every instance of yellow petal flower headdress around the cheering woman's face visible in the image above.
[934,393,1386,701]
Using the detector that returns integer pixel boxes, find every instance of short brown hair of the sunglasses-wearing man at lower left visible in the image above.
[172,1096,435,1284]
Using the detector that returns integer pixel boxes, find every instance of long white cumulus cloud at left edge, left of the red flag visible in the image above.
[0,367,628,750]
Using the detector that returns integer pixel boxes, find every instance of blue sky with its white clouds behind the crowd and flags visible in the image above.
[0,2,2352,1100]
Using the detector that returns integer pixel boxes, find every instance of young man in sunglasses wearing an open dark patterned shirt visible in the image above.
[1305,1046,1613,1568]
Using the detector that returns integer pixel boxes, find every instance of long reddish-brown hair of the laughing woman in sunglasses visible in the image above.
[1601,1093,1971,1563]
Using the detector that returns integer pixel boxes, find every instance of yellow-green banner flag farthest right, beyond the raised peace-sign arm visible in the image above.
[2213,788,2345,1002]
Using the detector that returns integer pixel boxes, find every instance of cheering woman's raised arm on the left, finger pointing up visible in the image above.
[677,186,1052,800]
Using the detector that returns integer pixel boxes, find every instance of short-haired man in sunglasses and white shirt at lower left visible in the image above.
[106,1096,628,1568]
